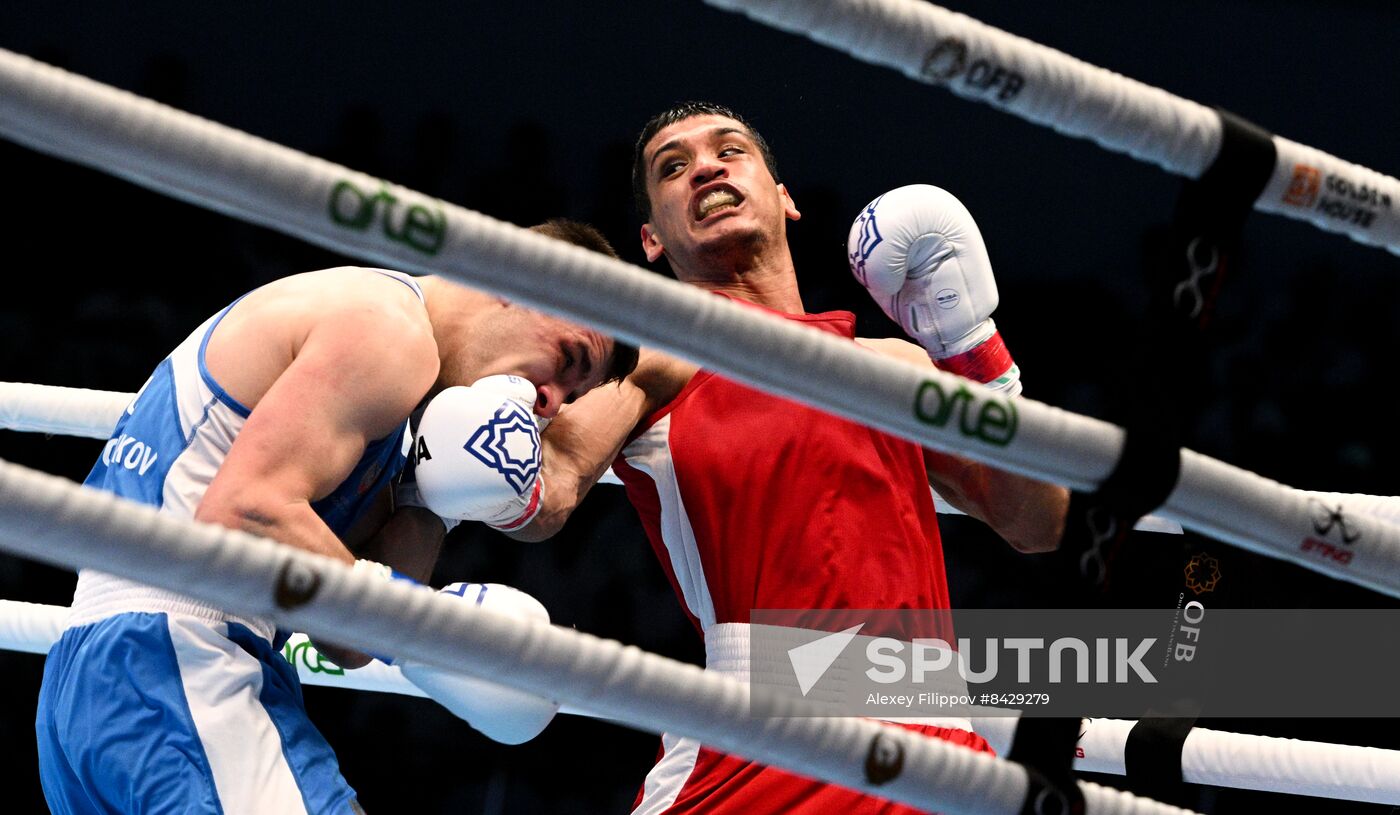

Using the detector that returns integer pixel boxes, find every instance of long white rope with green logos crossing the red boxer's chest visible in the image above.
[0,50,1400,597]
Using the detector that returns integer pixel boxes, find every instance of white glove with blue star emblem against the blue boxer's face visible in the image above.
[413,375,545,531]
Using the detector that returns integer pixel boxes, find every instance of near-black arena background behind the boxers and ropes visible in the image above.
[0,0,1400,814]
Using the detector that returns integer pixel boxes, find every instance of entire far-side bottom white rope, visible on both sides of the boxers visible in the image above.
[0,599,1400,804]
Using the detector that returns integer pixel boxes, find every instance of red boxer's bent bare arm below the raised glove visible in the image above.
[857,339,1070,552]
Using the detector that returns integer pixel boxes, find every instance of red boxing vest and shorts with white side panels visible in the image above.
[613,303,987,815]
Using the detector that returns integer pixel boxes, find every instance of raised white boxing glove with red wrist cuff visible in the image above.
[846,183,1021,396]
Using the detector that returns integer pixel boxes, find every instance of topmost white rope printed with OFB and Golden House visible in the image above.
[706,0,1400,255]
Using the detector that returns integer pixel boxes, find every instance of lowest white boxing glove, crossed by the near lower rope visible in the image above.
[395,583,559,744]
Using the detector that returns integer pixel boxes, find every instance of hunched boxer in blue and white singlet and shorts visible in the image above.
[35,224,636,814]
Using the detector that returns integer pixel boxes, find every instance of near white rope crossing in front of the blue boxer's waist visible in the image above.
[0,462,1204,815]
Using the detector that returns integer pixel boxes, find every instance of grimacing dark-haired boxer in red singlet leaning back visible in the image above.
[518,104,1068,815]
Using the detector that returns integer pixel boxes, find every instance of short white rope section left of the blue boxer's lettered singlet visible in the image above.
[0,382,126,438]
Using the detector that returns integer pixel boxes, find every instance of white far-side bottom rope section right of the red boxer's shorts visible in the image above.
[973,716,1400,804]
